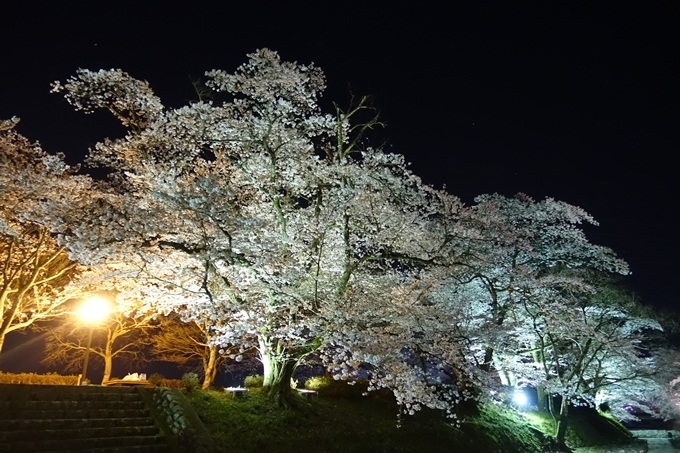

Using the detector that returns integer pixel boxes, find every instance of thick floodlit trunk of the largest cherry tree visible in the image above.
[258,336,299,407]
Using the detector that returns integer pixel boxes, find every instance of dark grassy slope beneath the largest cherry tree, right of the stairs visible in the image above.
[187,390,543,453]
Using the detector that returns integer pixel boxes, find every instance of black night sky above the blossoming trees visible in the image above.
[0,0,680,378]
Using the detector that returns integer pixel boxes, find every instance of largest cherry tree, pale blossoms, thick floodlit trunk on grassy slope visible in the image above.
[50,50,468,406]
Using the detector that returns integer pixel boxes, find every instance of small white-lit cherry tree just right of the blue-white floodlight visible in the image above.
[506,279,661,445]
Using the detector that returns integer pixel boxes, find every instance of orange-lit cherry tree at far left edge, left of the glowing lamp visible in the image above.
[0,122,92,350]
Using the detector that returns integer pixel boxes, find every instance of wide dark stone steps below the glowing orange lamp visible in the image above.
[0,384,171,453]
